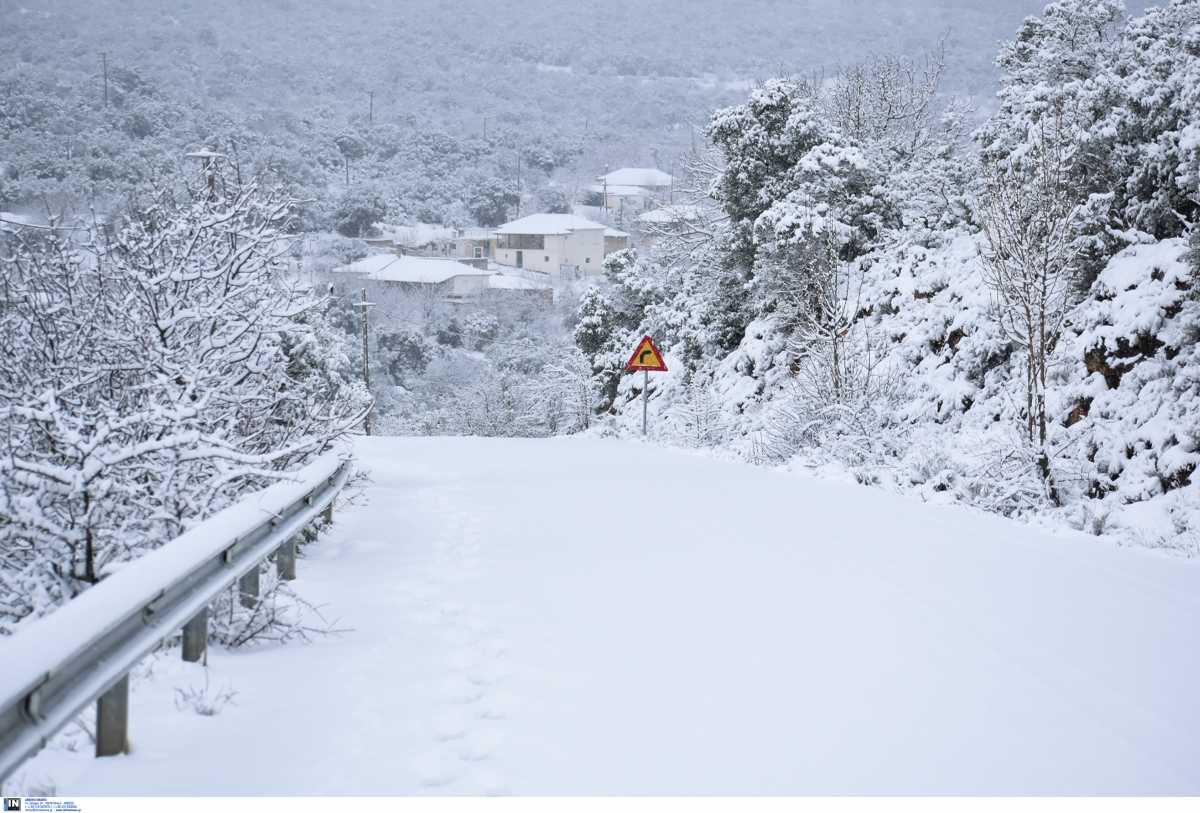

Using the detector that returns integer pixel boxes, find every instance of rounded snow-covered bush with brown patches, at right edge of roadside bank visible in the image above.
[1062,240,1200,513]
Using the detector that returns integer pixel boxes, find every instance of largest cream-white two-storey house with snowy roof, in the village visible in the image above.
[494,213,628,276]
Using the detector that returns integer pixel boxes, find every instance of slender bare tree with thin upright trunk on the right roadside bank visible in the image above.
[982,119,1080,504]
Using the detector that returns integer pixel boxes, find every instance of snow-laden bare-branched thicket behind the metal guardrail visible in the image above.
[0,169,366,628]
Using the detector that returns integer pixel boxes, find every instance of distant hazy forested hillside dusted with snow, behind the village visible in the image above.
[0,0,1084,228]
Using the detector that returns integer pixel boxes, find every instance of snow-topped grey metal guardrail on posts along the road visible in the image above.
[0,454,352,779]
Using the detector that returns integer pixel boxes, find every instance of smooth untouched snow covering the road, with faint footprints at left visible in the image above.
[6,438,1200,796]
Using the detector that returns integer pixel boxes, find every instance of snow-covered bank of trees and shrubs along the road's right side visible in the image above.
[600,0,1200,554]
